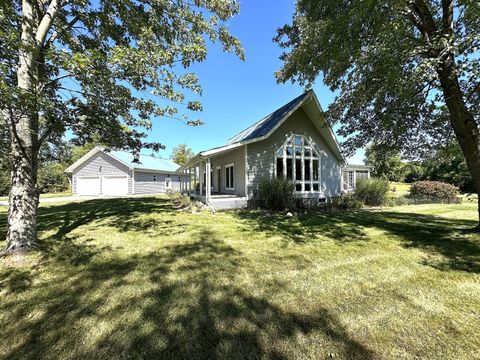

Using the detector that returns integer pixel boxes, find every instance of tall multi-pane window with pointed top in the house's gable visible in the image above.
[275,135,320,192]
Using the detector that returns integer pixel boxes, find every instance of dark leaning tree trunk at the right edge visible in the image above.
[437,54,480,231]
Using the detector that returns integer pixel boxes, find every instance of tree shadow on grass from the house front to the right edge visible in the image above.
[238,210,480,273]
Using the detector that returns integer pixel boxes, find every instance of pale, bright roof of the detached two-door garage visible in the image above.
[65,147,180,173]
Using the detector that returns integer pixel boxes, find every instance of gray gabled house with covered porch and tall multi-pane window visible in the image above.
[179,90,369,208]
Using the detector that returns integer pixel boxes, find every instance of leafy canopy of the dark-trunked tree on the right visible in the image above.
[275,0,480,158]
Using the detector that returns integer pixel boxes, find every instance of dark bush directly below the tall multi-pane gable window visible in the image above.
[258,178,295,210]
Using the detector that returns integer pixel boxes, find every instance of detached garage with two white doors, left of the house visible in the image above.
[66,147,189,196]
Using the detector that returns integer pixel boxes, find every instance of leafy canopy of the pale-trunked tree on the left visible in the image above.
[0,0,243,157]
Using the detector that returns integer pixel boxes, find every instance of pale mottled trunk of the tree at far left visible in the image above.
[5,0,38,252]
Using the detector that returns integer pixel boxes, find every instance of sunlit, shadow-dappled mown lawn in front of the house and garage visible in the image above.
[0,197,480,359]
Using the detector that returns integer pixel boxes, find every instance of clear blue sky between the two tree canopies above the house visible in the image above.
[144,0,364,163]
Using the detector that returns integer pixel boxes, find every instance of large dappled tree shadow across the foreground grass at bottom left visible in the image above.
[0,228,375,359]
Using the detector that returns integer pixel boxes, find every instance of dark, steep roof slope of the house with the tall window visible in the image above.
[227,91,310,145]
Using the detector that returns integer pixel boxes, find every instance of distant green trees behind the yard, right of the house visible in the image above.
[365,141,475,192]
